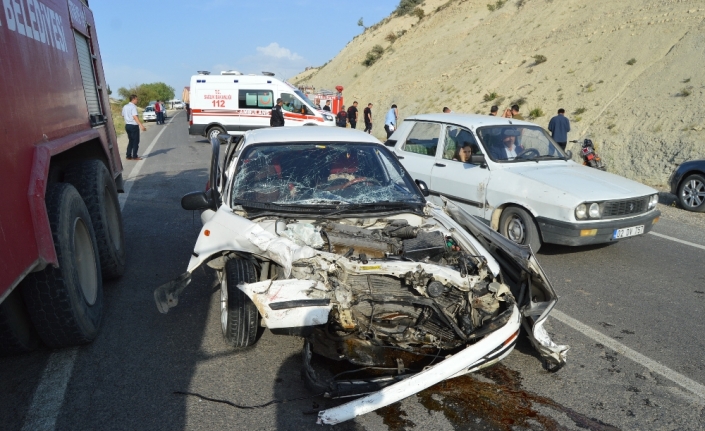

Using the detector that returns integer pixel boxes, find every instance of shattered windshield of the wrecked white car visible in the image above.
[232,142,425,206]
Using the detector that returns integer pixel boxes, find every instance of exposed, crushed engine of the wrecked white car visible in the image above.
[284,219,514,366]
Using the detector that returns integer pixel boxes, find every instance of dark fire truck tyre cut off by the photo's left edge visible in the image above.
[0,289,39,354]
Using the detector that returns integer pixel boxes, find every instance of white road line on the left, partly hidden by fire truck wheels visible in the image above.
[22,114,178,431]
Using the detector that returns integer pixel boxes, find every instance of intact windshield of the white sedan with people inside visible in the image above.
[477,125,566,163]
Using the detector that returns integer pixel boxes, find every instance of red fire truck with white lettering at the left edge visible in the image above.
[0,0,125,353]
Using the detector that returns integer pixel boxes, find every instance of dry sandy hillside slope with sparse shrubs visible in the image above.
[292,0,705,184]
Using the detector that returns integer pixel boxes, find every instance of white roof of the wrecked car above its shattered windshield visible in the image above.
[245,126,382,145]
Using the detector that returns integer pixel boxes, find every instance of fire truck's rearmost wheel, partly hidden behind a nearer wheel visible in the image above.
[64,160,126,279]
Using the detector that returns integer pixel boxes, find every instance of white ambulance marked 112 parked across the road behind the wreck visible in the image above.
[189,71,335,139]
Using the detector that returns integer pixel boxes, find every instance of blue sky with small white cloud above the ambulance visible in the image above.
[89,0,399,98]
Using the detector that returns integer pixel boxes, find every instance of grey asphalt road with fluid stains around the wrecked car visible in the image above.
[0,112,705,431]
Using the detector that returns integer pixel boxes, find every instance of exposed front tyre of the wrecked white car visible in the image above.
[220,259,260,349]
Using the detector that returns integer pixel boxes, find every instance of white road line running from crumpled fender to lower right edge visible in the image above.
[551,308,705,400]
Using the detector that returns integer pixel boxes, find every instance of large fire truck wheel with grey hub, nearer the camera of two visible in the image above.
[22,183,103,347]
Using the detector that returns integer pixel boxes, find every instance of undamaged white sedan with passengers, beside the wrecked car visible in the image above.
[386,114,661,252]
